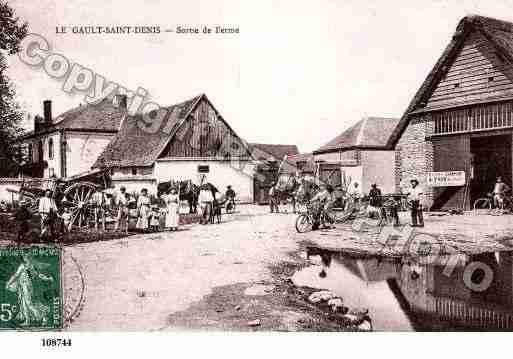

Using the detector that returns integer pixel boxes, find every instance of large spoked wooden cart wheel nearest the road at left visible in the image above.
[63,182,97,229]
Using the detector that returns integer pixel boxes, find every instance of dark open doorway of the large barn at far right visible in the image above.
[470,134,512,203]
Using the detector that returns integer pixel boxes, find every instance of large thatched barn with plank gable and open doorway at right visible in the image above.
[388,16,513,209]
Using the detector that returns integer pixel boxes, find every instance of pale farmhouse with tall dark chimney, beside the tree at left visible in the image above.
[19,95,127,177]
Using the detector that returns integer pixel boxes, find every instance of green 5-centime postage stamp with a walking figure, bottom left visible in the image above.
[0,247,63,330]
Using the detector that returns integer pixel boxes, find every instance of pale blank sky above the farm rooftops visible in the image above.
[8,0,513,152]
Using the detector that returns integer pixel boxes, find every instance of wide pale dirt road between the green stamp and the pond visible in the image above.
[64,206,308,330]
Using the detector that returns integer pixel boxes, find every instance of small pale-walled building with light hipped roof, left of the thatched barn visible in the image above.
[313,117,399,193]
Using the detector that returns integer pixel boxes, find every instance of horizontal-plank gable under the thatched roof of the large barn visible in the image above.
[427,31,513,107]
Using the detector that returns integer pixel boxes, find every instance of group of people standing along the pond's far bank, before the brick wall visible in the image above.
[310,179,424,230]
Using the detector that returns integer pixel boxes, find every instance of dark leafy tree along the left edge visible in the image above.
[0,0,28,177]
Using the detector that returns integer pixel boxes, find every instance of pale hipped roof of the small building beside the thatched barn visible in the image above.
[314,117,399,153]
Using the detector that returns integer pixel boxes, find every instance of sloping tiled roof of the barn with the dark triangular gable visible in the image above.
[93,95,204,168]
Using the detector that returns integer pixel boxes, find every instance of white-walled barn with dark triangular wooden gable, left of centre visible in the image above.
[93,94,254,202]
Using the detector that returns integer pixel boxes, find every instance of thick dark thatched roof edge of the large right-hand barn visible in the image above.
[387,15,513,148]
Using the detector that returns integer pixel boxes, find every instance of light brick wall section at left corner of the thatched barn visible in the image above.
[395,116,434,208]
